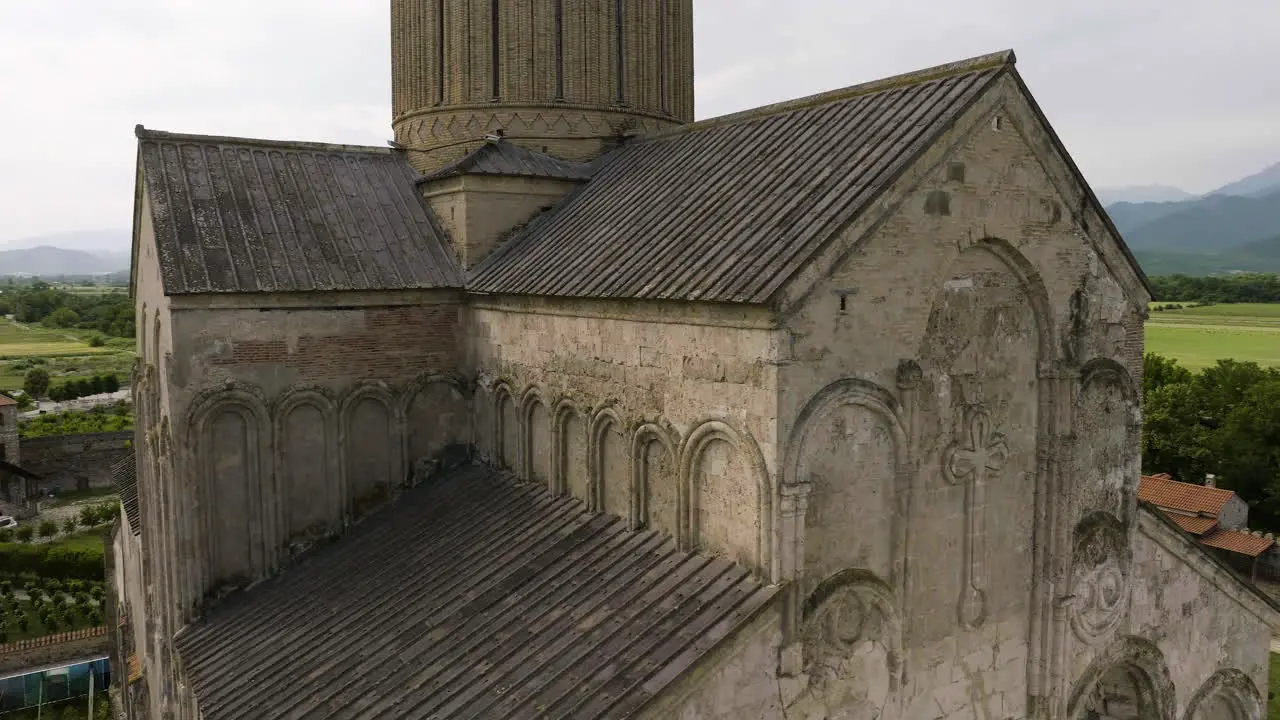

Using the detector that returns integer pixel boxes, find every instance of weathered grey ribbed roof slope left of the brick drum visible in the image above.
[137,126,463,295]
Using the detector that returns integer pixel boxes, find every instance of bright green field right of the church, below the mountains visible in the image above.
[1147,302,1280,370]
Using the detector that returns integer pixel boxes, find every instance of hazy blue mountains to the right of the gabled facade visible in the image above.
[1098,163,1280,275]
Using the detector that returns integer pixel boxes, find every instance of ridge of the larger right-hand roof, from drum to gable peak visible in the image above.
[640,50,1018,142]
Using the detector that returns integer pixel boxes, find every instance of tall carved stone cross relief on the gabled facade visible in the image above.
[942,407,1009,628]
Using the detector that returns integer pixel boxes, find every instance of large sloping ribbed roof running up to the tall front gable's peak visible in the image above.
[470,51,1014,302]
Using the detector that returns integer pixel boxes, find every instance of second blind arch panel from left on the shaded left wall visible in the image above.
[278,402,342,538]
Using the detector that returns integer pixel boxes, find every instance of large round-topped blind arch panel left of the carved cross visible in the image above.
[801,402,897,592]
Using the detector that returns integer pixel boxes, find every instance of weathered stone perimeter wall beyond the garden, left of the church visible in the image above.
[22,430,133,492]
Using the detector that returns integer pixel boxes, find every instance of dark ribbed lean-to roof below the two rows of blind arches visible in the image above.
[177,465,774,720]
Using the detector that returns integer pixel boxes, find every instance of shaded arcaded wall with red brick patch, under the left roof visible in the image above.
[165,292,470,617]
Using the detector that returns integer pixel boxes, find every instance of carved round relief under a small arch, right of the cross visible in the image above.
[1071,512,1130,643]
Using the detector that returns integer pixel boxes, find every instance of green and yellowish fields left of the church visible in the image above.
[0,318,133,389]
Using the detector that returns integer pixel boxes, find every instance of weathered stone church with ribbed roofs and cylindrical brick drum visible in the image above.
[113,0,1280,720]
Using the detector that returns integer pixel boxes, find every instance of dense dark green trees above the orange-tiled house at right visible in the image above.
[1142,354,1280,530]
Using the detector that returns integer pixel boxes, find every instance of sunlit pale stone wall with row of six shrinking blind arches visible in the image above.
[468,299,778,570]
